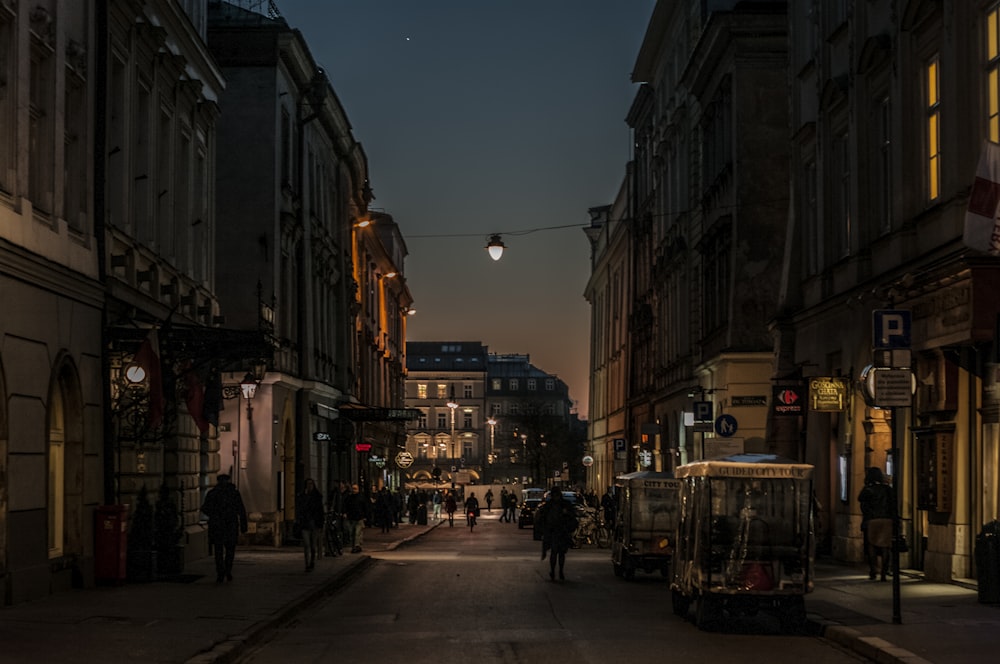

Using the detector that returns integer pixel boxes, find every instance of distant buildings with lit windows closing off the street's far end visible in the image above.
[406,341,585,484]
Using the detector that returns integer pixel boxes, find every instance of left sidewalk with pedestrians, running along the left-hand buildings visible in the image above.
[0,523,437,664]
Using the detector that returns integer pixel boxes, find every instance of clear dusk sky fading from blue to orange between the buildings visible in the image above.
[274,0,655,417]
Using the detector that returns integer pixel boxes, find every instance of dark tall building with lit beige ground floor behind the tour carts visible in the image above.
[616,2,788,478]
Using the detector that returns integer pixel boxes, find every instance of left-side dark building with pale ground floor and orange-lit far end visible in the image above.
[208,2,412,545]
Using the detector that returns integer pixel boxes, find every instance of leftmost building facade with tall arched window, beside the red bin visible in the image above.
[0,0,105,604]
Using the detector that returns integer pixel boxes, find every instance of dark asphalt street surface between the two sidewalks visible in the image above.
[240,510,868,664]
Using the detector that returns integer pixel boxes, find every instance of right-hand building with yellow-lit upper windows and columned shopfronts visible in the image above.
[775,0,1000,580]
